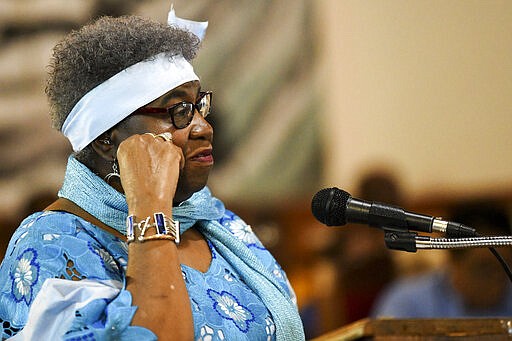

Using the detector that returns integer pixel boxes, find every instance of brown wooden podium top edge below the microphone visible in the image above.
[311,317,512,341]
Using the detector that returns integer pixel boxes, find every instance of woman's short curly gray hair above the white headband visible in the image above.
[46,16,200,158]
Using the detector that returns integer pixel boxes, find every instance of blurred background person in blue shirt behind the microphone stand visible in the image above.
[372,200,512,318]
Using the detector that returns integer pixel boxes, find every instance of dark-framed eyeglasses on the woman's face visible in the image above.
[135,91,212,129]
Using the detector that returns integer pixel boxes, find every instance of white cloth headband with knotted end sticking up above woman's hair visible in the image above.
[62,6,208,152]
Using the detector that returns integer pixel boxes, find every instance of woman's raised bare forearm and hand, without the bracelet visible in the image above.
[117,134,194,340]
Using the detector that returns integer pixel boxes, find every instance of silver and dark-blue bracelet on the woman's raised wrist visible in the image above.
[126,212,180,244]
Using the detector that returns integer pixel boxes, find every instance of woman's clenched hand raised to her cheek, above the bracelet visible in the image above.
[117,134,185,217]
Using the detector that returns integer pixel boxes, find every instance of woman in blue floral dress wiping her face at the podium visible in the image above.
[0,5,304,340]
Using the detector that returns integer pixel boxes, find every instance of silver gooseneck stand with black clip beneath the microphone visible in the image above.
[383,228,512,283]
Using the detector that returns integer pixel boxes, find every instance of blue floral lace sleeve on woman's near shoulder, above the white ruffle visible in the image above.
[0,211,126,328]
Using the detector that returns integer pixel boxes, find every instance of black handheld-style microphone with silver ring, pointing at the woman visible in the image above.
[311,187,477,238]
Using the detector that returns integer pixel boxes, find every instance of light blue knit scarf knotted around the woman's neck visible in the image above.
[59,156,305,341]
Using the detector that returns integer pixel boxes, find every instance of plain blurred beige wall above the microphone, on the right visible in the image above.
[315,0,512,196]
